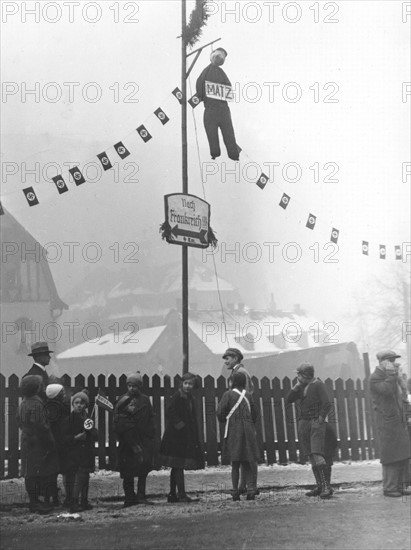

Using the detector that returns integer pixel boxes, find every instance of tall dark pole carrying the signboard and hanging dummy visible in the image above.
[181,0,188,374]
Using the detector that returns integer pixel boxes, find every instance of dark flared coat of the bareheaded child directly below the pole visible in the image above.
[160,388,204,467]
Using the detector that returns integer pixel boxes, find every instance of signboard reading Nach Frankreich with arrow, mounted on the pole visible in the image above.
[164,193,210,248]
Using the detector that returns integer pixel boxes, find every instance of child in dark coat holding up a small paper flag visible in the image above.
[62,391,97,513]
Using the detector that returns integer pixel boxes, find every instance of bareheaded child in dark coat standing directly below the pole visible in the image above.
[160,372,204,502]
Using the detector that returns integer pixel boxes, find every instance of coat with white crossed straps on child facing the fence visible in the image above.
[217,390,259,462]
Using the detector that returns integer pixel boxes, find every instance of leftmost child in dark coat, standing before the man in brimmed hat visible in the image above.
[17,375,58,514]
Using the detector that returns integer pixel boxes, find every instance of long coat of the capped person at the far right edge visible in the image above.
[370,367,411,464]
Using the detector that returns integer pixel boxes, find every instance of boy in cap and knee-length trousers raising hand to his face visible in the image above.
[286,363,333,499]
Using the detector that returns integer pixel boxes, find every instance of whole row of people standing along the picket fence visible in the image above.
[18,342,411,514]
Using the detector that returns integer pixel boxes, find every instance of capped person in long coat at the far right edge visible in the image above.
[370,350,411,497]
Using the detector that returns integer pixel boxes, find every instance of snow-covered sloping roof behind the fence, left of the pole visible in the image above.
[56,325,166,360]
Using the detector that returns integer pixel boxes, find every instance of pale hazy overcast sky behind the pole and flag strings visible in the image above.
[2,0,411,354]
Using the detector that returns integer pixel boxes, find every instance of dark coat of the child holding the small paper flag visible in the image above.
[61,412,98,472]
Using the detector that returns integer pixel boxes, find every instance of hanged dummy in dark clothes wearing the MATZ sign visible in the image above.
[196,48,240,160]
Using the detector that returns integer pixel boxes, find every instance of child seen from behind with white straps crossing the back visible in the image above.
[217,372,259,500]
